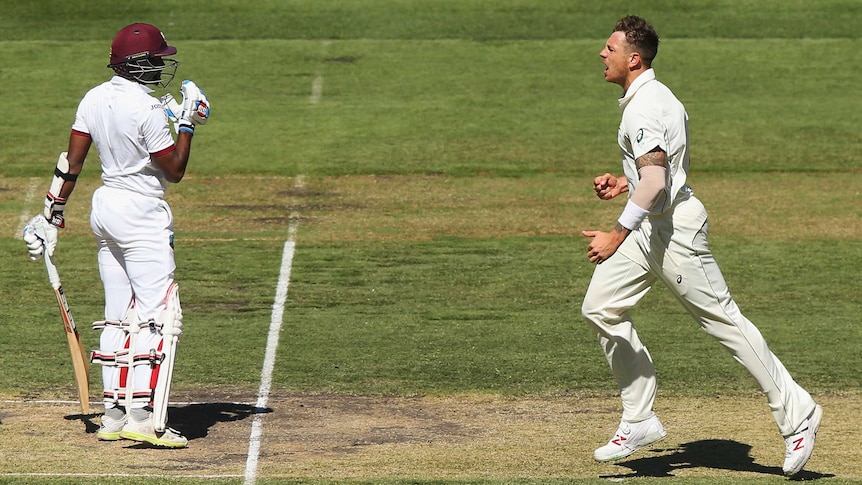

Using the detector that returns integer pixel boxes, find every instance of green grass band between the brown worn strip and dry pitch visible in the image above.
[5,223,862,395]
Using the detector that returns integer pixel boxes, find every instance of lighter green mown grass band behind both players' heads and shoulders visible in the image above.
[0,39,862,176]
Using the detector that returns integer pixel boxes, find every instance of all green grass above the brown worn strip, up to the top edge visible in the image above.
[0,0,862,176]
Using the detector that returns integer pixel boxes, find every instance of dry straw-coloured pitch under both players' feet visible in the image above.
[0,392,862,481]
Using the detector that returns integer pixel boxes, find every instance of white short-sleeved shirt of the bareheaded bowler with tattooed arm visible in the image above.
[617,69,691,215]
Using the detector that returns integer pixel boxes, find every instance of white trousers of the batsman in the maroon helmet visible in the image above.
[90,186,176,407]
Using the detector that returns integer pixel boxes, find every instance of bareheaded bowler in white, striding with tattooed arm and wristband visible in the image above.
[582,16,823,476]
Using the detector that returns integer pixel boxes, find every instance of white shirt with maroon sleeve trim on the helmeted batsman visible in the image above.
[72,76,175,197]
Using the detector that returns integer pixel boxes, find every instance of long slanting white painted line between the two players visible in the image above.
[243,213,296,485]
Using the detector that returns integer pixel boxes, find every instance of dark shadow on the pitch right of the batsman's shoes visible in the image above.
[168,402,273,441]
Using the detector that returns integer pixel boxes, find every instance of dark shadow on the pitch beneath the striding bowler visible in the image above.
[600,440,835,480]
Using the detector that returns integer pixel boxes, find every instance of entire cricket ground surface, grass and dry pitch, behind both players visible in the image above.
[0,0,862,484]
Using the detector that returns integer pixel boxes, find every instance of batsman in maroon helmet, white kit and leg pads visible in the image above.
[24,23,210,448]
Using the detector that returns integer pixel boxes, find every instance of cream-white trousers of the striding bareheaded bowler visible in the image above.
[582,196,815,436]
